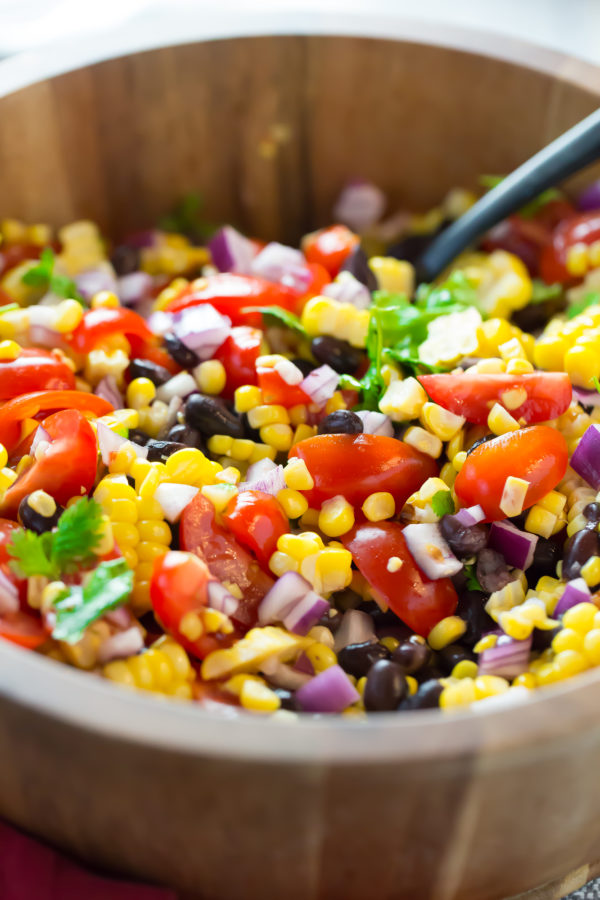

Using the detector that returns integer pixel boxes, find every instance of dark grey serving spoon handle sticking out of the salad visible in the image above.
[416,109,600,281]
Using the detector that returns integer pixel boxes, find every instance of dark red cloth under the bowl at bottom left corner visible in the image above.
[0,821,177,900]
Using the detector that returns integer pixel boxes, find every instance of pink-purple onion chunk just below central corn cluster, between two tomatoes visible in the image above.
[258,572,329,634]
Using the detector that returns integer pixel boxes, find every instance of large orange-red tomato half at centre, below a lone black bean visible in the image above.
[289,434,438,509]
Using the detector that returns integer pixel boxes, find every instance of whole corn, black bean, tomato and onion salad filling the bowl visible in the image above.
[0,178,600,718]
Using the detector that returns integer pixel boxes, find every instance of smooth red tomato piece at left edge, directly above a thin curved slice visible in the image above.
[0,348,75,400]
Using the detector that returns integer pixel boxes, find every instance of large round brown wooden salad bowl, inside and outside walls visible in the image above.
[0,23,600,900]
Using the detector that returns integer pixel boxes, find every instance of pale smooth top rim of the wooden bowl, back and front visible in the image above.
[0,22,600,768]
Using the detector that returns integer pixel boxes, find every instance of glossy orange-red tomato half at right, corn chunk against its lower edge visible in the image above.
[454,425,569,521]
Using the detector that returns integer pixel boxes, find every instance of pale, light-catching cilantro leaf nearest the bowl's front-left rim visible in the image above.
[52,559,133,644]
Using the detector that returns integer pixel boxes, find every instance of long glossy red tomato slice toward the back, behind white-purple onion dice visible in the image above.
[167,272,298,325]
